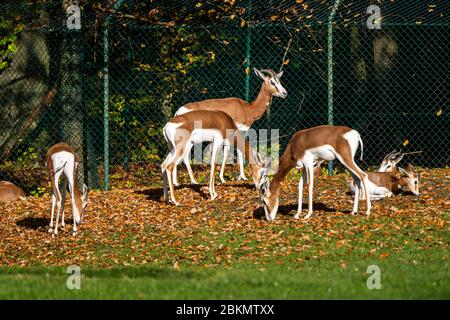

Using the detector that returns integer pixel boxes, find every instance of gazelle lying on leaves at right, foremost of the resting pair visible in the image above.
[350,164,420,200]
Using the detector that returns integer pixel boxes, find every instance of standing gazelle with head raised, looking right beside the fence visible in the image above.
[173,68,287,185]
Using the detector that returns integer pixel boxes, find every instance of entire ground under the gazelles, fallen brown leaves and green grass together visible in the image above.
[0,169,450,299]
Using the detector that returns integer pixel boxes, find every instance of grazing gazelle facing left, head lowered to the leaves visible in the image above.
[260,126,371,220]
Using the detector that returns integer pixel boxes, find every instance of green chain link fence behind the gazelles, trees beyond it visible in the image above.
[0,0,450,191]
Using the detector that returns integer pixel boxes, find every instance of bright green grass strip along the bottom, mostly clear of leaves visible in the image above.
[0,256,450,299]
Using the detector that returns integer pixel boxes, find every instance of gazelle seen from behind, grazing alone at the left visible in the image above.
[45,142,88,235]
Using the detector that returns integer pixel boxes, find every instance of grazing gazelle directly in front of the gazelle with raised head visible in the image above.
[161,110,267,205]
